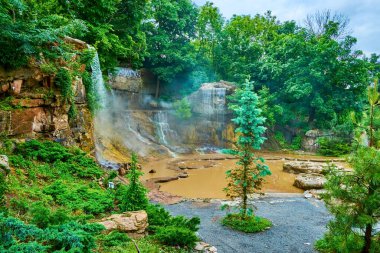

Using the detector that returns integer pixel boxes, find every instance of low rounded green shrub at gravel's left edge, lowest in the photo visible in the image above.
[154,226,198,248]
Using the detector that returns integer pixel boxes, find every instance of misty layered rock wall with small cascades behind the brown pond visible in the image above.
[96,74,235,162]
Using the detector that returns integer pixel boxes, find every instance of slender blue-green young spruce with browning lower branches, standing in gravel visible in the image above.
[225,81,271,219]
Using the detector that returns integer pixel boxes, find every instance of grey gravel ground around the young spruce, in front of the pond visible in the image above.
[166,196,331,253]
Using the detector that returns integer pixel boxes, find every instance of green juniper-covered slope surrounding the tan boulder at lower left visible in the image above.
[0,140,200,253]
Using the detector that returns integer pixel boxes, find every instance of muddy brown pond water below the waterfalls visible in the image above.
[143,152,344,199]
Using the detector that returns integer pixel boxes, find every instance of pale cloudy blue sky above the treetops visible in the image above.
[193,0,380,54]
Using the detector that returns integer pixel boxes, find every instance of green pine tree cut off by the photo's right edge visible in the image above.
[316,80,380,253]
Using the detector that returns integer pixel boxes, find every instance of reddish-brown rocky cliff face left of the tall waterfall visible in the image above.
[0,67,94,151]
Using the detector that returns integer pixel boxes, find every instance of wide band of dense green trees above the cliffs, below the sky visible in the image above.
[0,0,380,135]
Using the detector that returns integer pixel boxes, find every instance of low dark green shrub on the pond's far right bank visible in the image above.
[318,137,351,156]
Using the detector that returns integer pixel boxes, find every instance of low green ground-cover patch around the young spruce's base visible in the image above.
[222,214,272,233]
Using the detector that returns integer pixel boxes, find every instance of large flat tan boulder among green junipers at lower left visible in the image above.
[98,210,148,239]
